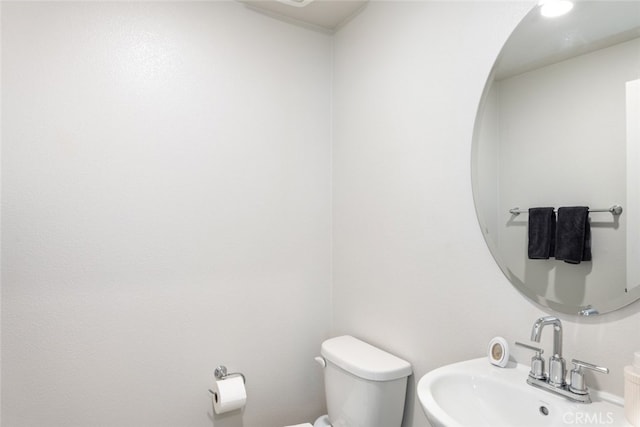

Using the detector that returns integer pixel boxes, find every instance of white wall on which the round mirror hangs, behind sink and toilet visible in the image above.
[333,2,640,427]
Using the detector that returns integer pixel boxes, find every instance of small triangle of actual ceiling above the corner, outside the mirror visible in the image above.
[239,0,368,33]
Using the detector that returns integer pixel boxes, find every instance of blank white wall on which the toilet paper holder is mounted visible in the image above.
[2,2,331,427]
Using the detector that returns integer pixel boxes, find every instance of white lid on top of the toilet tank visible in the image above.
[321,335,412,381]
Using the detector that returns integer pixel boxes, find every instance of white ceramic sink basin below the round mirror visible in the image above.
[417,357,631,427]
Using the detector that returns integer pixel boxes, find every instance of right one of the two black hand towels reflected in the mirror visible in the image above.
[556,206,591,264]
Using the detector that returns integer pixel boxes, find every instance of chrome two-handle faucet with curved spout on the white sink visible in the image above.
[516,316,609,403]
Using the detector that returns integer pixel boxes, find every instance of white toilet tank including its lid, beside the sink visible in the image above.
[321,335,412,427]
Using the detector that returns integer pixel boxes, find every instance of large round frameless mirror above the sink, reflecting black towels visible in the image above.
[472,0,640,315]
